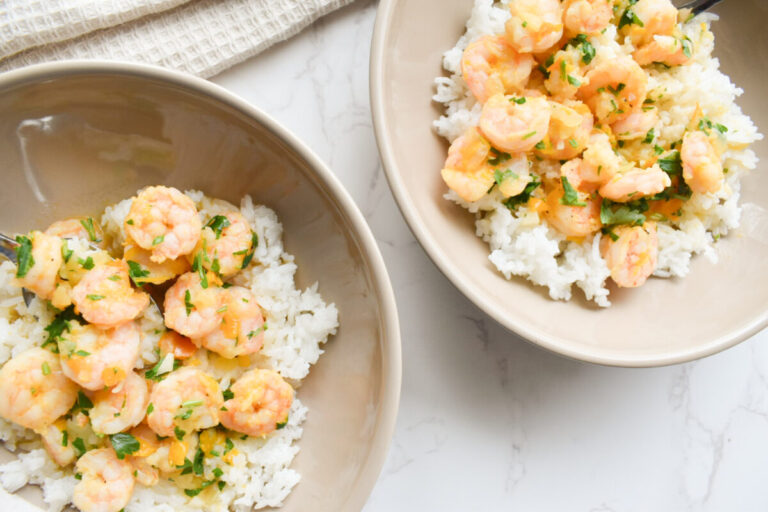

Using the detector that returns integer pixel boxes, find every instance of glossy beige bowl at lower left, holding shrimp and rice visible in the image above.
[0,62,401,512]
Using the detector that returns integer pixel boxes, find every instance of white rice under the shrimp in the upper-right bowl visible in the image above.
[433,0,762,307]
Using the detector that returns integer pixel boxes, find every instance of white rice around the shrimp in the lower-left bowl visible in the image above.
[0,191,338,512]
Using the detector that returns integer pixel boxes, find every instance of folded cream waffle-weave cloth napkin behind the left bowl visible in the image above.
[0,0,353,77]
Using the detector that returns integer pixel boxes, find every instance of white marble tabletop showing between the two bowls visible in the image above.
[214,0,768,512]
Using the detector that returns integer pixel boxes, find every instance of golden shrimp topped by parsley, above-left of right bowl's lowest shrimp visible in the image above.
[545,182,602,237]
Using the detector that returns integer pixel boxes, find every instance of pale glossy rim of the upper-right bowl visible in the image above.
[369,0,768,368]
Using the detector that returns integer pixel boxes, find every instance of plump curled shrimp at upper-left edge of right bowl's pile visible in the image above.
[461,36,534,103]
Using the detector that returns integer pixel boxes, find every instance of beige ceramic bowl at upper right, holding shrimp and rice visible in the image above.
[371,0,768,366]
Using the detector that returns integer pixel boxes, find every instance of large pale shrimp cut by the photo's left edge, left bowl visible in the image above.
[0,347,77,431]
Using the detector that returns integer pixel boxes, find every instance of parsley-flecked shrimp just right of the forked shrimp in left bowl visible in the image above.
[72,260,149,328]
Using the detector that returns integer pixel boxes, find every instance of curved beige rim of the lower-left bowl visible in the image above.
[0,60,402,510]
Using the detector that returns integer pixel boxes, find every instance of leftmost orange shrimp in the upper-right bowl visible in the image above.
[440,127,494,202]
